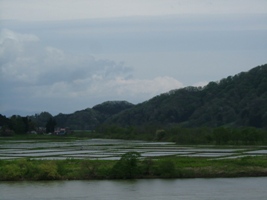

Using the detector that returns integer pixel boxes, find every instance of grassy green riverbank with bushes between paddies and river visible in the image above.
[0,152,267,181]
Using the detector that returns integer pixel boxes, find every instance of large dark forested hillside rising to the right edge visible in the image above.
[106,64,267,128]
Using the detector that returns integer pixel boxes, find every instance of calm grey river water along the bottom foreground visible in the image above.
[0,177,267,200]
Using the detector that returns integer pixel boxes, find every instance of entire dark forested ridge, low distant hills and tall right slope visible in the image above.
[0,64,267,130]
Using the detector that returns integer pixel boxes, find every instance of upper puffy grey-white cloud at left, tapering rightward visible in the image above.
[0,30,131,84]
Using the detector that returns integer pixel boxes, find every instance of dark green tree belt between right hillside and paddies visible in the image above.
[97,125,267,145]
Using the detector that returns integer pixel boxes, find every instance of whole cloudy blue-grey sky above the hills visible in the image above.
[0,0,267,116]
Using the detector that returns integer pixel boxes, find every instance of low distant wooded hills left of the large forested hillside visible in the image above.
[0,101,134,135]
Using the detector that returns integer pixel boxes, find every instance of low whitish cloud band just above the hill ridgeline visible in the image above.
[29,76,183,103]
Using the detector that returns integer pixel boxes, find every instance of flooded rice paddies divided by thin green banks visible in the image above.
[0,139,267,160]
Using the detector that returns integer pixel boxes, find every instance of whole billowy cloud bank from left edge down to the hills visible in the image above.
[0,29,183,114]
